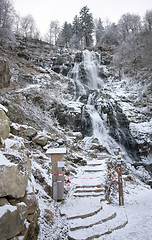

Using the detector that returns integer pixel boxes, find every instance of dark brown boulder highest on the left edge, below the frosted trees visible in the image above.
[0,58,11,89]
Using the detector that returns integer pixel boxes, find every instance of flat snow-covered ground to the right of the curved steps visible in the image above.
[102,182,152,240]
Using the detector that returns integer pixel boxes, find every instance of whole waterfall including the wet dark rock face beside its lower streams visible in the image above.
[67,50,136,157]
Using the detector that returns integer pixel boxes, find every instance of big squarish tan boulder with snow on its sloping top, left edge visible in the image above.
[0,152,27,198]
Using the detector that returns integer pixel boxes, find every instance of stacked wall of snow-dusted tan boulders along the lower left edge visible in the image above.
[0,105,39,240]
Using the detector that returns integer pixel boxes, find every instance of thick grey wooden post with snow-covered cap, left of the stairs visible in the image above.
[46,148,66,201]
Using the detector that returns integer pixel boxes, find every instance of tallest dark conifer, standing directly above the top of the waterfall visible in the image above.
[80,6,94,47]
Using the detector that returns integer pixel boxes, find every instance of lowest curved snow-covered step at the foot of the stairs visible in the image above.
[68,207,128,240]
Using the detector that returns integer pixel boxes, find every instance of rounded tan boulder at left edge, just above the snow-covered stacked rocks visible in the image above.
[0,107,10,139]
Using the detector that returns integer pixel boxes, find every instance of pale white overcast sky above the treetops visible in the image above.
[13,0,152,34]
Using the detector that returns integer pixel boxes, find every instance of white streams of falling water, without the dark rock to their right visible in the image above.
[71,50,117,152]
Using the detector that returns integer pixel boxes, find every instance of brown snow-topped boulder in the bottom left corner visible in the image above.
[0,203,27,240]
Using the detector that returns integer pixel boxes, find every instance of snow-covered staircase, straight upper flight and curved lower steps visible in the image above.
[61,156,128,240]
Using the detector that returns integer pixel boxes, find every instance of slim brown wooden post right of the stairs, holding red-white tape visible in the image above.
[117,148,124,206]
